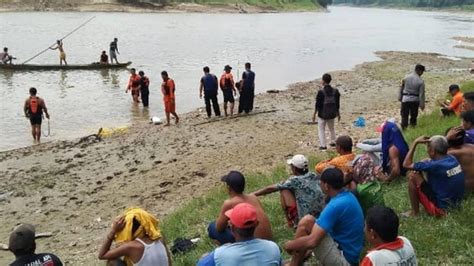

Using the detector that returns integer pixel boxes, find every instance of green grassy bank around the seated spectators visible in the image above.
[162,81,474,265]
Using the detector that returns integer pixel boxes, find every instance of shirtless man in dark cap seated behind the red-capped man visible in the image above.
[207,171,272,245]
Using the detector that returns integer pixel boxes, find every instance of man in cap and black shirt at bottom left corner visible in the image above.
[8,224,63,266]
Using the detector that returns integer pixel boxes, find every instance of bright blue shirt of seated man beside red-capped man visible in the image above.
[316,191,364,263]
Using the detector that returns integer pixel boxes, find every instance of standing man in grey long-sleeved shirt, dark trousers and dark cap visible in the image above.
[398,64,425,130]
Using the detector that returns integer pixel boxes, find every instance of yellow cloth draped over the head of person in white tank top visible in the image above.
[115,207,161,265]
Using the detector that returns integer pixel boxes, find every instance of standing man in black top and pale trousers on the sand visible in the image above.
[313,73,341,150]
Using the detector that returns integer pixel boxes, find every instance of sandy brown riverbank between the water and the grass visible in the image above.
[0,52,473,265]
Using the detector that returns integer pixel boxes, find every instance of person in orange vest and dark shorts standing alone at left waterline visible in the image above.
[23,87,49,143]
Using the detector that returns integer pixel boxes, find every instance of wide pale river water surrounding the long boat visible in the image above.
[0,7,474,150]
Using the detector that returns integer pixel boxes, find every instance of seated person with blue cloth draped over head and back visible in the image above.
[378,121,408,182]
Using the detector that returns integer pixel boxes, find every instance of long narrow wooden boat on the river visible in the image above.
[0,61,132,71]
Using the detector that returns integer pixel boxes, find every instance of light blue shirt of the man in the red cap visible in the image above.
[197,238,282,266]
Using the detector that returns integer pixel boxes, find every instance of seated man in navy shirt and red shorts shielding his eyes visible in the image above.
[403,136,464,217]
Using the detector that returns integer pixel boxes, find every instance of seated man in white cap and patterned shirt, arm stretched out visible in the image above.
[253,154,324,227]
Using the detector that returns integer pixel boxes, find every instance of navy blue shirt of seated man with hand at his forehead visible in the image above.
[413,155,464,209]
